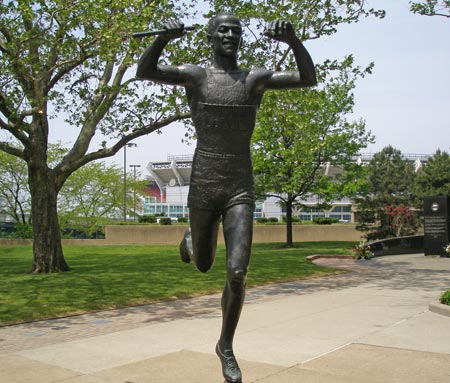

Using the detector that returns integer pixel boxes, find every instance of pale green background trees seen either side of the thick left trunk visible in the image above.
[0,143,143,237]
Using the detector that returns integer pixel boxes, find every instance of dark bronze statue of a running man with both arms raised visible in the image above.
[137,13,317,383]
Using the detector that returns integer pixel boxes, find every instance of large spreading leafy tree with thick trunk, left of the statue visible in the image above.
[0,0,384,272]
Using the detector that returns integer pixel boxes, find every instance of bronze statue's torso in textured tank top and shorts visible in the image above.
[188,70,259,211]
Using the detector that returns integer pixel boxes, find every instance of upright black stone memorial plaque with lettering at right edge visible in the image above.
[424,196,450,257]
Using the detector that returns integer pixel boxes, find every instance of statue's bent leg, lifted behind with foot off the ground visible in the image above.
[184,209,220,273]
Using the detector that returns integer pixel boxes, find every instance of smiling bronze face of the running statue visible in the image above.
[210,15,242,56]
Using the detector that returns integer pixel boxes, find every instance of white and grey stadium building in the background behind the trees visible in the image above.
[143,154,430,222]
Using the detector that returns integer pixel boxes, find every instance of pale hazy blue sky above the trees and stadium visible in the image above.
[45,0,450,173]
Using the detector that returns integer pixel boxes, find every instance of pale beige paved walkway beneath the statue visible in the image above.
[0,255,450,383]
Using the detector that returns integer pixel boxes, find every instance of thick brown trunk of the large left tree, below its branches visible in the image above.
[29,163,69,273]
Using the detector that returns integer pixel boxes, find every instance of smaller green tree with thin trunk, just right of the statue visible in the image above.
[253,56,373,246]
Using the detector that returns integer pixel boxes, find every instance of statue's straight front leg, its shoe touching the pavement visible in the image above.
[216,204,253,382]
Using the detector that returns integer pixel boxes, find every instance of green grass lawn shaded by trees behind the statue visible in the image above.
[0,242,354,324]
